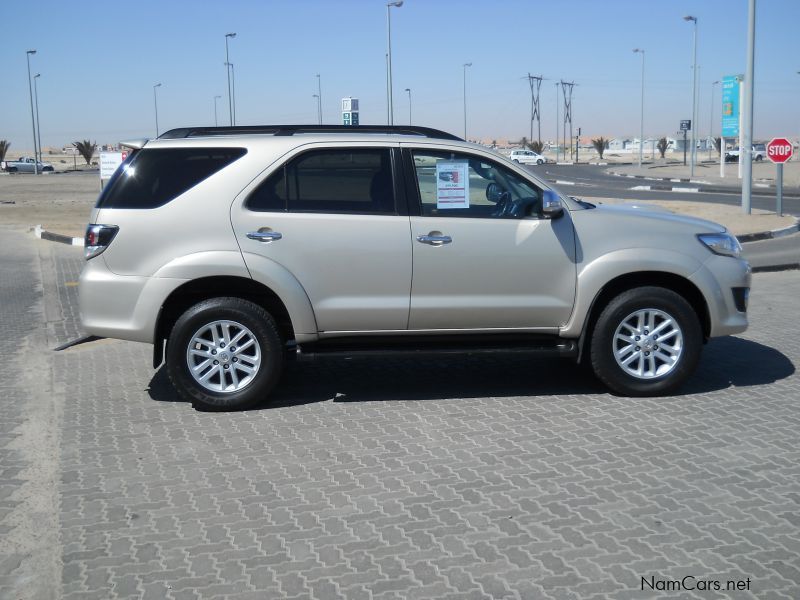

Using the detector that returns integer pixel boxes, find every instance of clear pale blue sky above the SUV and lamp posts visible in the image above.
[0,0,800,155]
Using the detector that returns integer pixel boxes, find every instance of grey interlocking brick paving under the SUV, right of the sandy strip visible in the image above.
[0,232,800,600]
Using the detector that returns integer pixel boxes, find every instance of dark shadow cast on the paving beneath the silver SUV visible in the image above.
[147,337,795,410]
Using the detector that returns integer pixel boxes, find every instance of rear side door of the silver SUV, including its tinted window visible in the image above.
[231,144,411,332]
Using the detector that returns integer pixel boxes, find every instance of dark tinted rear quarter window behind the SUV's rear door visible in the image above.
[97,148,247,208]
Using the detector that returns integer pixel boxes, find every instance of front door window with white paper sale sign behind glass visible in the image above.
[413,150,542,219]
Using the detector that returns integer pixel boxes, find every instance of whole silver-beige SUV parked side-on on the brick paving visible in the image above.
[80,126,750,410]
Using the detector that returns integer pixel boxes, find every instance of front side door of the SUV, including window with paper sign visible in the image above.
[406,148,577,330]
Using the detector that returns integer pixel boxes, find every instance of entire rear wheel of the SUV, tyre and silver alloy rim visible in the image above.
[167,297,283,411]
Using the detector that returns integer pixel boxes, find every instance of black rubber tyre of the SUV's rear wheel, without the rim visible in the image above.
[166,297,283,410]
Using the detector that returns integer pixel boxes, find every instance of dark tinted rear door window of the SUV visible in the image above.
[246,148,396,214]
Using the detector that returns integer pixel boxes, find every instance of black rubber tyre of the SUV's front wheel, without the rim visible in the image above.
[591,287,703,396]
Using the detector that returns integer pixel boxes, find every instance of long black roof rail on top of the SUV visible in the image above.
[158,125,463,141]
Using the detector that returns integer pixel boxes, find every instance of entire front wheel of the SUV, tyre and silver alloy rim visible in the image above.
[590,287,703,396]
